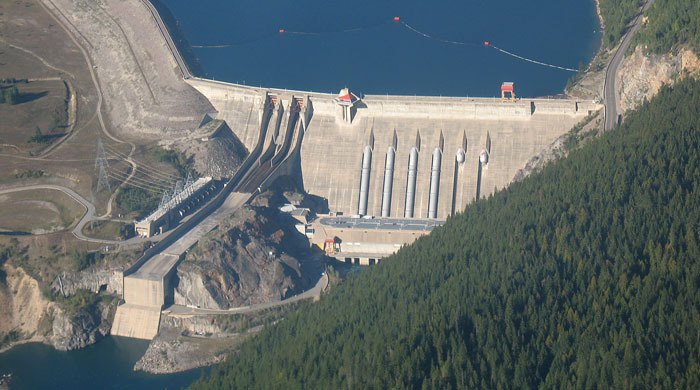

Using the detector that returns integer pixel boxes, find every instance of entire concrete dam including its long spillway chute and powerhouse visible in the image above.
[112,84,600,339]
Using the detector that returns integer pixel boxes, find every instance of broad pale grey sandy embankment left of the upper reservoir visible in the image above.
[41,0,213,139]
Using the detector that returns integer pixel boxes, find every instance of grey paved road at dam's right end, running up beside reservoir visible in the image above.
[603,0,655,131]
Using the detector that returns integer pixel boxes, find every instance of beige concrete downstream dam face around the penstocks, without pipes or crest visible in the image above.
[301,112,583,218]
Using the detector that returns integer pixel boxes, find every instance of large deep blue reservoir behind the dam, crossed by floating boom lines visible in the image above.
[159,0,600,97]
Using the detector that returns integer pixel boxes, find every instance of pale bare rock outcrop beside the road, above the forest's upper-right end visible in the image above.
[616,47,700,112]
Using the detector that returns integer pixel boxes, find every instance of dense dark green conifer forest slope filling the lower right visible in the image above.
[194,81,700,389]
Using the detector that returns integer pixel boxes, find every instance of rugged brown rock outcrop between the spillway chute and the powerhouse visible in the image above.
[175,207,304,309]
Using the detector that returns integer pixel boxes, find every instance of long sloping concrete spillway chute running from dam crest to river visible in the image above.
[111,94,308,340]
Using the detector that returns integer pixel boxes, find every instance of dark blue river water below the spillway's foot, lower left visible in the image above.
[0,337,202,389]
